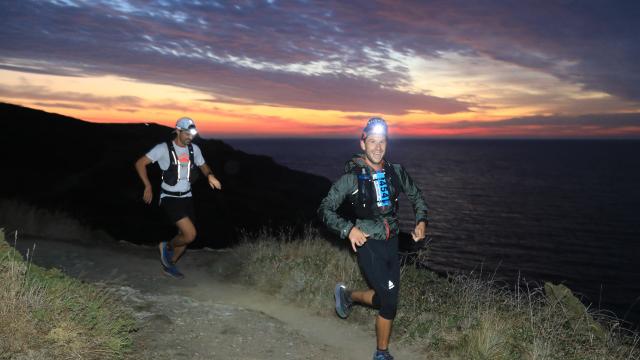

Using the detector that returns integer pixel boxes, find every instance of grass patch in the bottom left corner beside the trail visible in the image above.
[0,229,135,359]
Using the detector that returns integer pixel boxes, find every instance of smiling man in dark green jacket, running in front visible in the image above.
[318,118,428,360]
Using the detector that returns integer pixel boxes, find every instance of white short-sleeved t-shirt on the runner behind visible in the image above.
[146,141,204,198]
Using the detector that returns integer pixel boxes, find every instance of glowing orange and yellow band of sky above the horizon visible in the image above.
[0,59,640,137]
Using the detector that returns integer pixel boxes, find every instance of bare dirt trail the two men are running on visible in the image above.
[16,237,423,360]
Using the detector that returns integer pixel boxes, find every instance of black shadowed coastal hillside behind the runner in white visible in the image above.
[0,104,331,247]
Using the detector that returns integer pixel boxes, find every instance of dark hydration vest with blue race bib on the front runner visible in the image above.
[349,161,402,219]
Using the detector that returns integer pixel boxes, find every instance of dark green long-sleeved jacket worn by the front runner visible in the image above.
[318,155,428,240]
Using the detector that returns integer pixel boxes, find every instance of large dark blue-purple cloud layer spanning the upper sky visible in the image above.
[0,0,640,114]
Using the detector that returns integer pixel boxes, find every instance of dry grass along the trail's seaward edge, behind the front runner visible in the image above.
[234,229,640,360]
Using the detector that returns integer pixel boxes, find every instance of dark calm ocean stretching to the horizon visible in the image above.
[225,139,640,326]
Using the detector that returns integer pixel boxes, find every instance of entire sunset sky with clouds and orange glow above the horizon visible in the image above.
[0,0,640,138]
